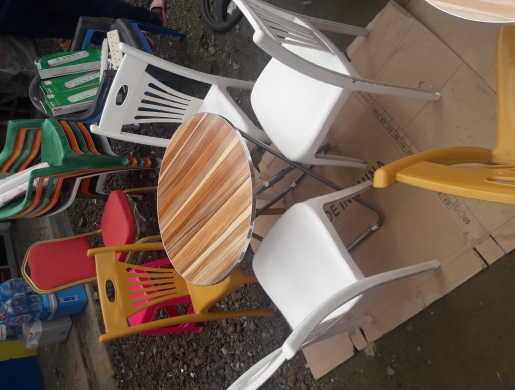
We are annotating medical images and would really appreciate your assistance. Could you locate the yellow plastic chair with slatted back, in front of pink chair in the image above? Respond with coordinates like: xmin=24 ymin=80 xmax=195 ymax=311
xmin=88 ymin=243 xmax=273 ymax=343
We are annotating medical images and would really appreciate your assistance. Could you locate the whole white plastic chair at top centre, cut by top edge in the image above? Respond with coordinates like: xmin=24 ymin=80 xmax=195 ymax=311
xmin=234 ymin=0 xmax=440 ymax=168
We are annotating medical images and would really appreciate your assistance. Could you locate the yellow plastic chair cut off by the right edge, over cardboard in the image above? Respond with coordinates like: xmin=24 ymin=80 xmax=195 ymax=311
xmin=374 ymin=25 xmax=515 ymax=204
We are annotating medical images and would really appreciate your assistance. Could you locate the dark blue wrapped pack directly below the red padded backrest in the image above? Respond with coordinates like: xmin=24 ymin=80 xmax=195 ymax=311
xmin=40 ymin=286 xmax=88 ymax=321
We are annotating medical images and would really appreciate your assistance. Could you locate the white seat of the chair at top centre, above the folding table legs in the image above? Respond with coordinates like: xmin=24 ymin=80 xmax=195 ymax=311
xmin=251 ymin=58 xmax=352 ymax=164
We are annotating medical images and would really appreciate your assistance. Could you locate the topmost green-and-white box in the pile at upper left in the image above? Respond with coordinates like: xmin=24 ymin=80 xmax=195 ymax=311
xmin=34 ymin=49 xmax=102 ymax=80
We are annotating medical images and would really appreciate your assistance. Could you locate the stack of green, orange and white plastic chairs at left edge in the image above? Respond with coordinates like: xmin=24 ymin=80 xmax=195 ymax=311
xmin=0 ymin=119 xmax=160 ymax=219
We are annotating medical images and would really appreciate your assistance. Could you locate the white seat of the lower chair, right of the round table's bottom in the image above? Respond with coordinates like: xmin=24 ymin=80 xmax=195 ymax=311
xmin=253 ymin=198 xmax=364 ymax=329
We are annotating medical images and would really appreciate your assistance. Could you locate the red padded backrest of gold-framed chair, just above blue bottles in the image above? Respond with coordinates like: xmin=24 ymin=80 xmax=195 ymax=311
xmin=27 ymin=237 xmax=97 ymax=290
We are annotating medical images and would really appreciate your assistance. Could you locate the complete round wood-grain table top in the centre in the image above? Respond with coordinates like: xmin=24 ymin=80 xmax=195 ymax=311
xmin=157 ymin=114 xmax=255 ymax=286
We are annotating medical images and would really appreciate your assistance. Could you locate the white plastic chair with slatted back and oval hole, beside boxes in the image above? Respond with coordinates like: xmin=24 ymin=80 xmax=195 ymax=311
xmin=91 ymin=43 xmax=270 ymax=147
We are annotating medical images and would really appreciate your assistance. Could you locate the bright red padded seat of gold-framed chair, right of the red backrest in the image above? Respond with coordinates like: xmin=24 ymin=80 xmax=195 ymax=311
xmin=100 ymin=190 xmax=138 ymax=261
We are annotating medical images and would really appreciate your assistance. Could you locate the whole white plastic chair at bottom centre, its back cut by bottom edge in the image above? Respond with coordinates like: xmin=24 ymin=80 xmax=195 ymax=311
xmin=229 ymin=181 xmax=440 ymax=390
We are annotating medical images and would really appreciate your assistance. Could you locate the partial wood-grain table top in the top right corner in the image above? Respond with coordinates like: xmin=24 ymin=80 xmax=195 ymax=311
xmin=426 ymin=0 xmax=515 ymax=23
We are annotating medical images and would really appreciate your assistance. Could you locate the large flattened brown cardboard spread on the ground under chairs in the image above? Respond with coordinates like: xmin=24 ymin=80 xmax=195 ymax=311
xmin=254 ymin=0 xmax=515 ymax=378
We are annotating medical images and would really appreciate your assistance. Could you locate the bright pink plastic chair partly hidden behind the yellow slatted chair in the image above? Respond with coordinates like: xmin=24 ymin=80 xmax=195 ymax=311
xmin=129 ymin=258 xmax=204 ymax=334
